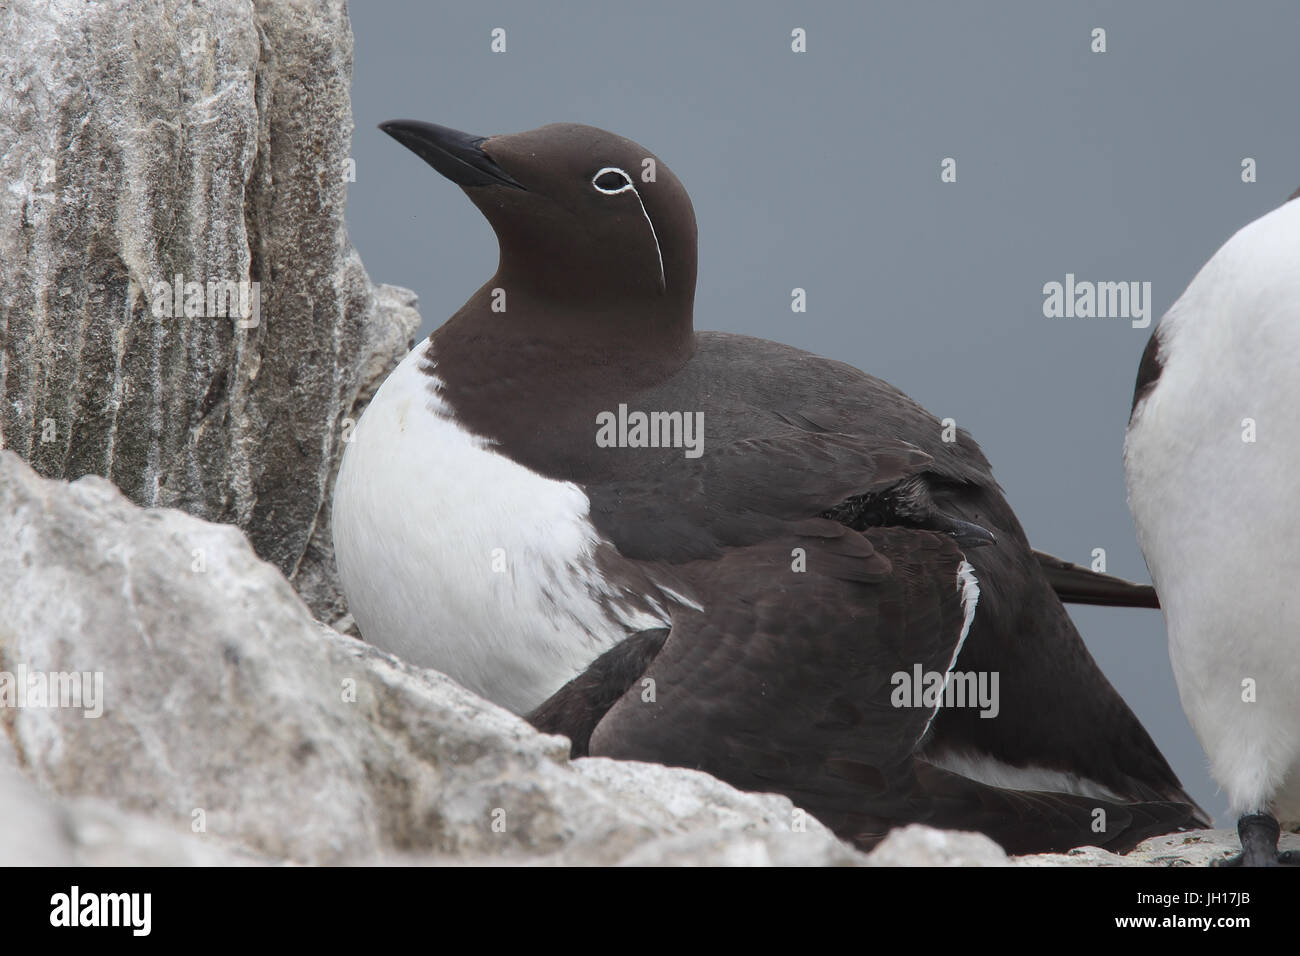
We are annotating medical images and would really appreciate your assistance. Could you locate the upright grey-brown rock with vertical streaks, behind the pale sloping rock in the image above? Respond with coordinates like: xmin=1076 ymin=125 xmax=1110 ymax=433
xmin=0 ymin=0 xmax=419 ymax=620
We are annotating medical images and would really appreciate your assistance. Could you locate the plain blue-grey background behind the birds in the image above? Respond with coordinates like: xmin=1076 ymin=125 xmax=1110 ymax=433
xmin=347 ymin=0 xmax=1300 ymax=823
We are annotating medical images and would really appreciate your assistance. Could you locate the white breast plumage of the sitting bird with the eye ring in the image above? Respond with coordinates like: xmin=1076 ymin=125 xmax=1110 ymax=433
xmin=333 ymin=342 xmax=667 ymax=713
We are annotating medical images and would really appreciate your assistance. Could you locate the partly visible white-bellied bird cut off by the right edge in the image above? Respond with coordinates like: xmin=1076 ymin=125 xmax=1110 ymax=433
xmin=1125 ymin=191 xmax=1300 ymax=866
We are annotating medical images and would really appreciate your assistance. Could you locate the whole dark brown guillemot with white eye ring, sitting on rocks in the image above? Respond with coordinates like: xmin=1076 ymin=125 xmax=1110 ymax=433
xmin=334 ymin=121 xmax=1199 ymax=852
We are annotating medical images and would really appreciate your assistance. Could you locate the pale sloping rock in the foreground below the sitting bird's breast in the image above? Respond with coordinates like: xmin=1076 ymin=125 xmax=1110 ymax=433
xmin=0 ymin=451 xmax=862 ymax=865
